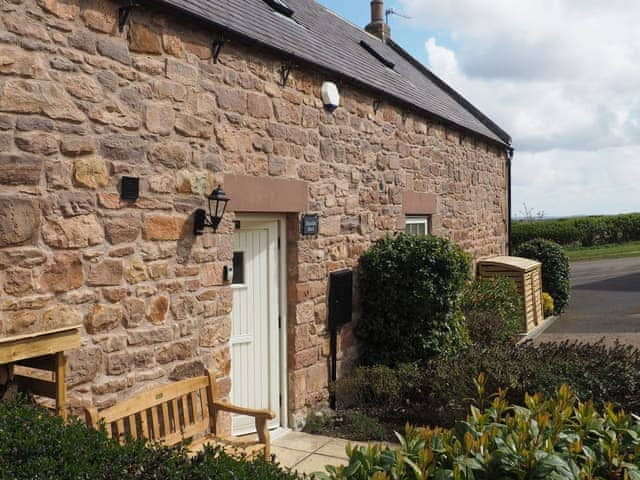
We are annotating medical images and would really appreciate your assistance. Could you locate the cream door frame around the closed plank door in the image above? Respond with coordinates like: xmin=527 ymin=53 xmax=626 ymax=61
xmin=231 ymin=213 xmax=289 ymax=428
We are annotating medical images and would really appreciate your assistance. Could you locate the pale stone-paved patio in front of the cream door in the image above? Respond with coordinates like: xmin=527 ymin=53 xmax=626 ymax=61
xmin=271 ymin=432 xmax=390 ymax=474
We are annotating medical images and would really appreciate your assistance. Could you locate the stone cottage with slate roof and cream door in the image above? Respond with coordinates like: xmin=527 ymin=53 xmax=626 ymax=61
xmin=0 ymin=0 xmax=511 ymax=432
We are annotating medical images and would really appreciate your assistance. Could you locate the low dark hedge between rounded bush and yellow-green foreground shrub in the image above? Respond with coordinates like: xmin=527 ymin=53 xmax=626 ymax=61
xmin=333 ymin=342 xmax=640 ymax=427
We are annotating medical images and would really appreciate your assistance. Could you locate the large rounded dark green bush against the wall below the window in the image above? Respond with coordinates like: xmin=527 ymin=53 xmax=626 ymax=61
xmin=356 ymin=234 xmax=470 ymax=365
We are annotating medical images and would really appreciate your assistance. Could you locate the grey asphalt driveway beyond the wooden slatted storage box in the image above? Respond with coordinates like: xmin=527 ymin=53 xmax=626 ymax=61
xmin=536 ymin=257 xmax=640 ymax=348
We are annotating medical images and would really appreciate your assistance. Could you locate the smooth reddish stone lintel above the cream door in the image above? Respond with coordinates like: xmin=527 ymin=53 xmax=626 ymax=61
xmin=224 ymin=175 xmax=309 ymax=213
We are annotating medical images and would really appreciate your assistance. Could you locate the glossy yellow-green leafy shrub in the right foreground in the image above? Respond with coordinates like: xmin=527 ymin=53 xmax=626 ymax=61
xmin=320 ymin=378 xmax=640 ymax=480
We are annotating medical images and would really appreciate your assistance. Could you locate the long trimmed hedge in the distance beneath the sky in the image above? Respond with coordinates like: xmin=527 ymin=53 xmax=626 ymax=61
xmin=511 ymin=213 xmax=640 ymax=247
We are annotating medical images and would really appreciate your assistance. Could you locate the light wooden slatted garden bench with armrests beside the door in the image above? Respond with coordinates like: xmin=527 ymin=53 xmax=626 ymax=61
xmin=86 ymin=371 xmax=276 ymax=459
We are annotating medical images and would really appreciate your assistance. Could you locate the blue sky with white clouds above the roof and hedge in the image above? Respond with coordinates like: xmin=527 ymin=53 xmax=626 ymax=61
xmin=319 ymin=0 xmax=640 ymax=216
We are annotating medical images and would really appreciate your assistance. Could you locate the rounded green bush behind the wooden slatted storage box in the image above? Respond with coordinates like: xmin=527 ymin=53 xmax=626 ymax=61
xmin=515 ymin=239 xmax=571 ymax=315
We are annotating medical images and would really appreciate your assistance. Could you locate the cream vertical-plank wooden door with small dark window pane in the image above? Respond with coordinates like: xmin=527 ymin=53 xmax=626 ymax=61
xmin=231 ymin=220 xmax=280 ymax=435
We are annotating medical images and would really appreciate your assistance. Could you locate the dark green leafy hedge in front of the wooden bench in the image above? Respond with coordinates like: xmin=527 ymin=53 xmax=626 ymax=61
xmin=0 ymin=399 xmax=299 ymax=480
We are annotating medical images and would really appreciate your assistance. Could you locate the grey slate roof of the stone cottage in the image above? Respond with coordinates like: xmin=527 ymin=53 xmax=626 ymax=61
xmin=154 ymin=0 xmax=511 ymax=145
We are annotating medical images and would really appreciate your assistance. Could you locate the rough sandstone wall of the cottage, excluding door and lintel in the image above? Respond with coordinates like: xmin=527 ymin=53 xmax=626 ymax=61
xmin=0 ymin=0 xmax=506 ymax=428
